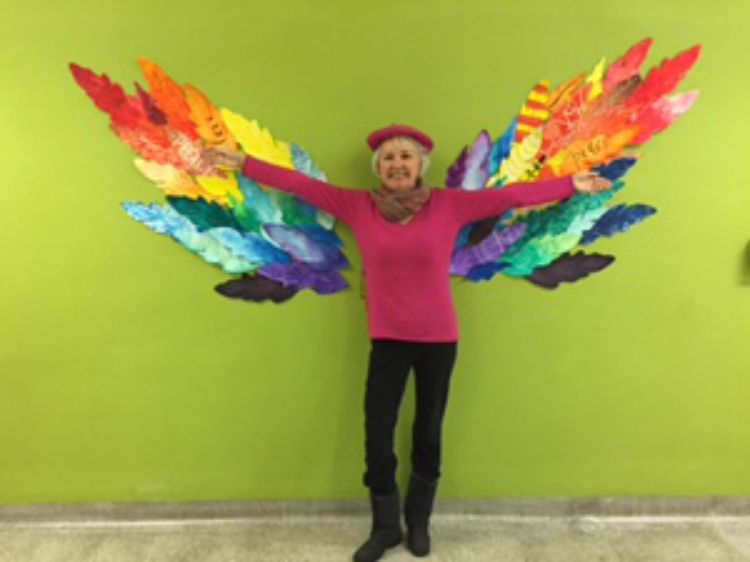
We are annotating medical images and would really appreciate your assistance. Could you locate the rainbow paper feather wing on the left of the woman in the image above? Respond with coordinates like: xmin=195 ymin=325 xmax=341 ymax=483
xmin=70 ymin=60 xmax=349 ymax=302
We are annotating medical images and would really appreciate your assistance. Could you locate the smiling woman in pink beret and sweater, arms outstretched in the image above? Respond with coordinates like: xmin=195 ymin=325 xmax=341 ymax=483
xmin=209 ymin=125 xmax=610 ymax=562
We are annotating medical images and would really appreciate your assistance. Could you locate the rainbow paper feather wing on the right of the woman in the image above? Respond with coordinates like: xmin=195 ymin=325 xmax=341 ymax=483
xmin=446 ymin=39 xmax=700 ymax=288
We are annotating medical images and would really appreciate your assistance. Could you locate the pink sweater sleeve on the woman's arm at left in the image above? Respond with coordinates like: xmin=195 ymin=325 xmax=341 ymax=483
xmin=242 ymin=156 xmax=369 ymax=224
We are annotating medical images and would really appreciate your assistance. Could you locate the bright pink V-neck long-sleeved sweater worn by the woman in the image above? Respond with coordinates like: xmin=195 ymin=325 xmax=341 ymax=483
xmin=243 ymin=158 xmax=575 ymax=342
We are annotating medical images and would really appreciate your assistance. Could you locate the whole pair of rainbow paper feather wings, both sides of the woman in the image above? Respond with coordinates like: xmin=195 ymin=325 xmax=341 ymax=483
xmin=70 ymin=40 xmax=700 ymax=302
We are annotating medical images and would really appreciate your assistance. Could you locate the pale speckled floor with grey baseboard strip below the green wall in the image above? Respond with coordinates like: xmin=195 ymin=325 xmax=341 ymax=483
xmin=0 ymin=498 xmax=750 ymax=562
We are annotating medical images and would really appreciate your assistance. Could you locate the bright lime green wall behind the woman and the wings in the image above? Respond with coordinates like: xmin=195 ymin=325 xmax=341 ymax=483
xmin=0 ymin=0 xmax=750 ymax=498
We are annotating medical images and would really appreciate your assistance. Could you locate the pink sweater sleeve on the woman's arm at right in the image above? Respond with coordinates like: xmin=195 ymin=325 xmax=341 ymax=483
xmin=448 ymin=176 xmax=576 ymax=225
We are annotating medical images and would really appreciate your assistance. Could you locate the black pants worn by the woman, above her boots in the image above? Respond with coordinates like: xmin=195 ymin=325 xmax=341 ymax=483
xmin=364 ymin=334 xmax=457 ymax=495
